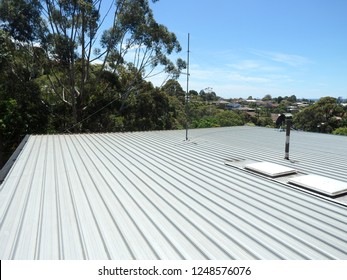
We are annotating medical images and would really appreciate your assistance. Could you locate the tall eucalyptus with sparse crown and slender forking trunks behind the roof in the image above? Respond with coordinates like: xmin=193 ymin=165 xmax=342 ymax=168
xmin=44 ymin=0 xmax=184 ymax=130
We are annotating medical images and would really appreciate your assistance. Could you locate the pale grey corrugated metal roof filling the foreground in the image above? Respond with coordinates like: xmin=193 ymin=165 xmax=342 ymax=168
xmin=0 ymin=127 xmax=347 ymax=260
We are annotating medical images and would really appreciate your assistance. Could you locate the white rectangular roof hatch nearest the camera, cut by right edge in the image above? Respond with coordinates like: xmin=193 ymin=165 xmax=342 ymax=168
xmin=288 ymin=174 xmax=347 ymax=197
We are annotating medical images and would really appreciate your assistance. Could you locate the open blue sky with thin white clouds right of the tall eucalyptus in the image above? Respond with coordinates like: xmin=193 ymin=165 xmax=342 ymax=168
xmin=147 ymin=0 xmax=347 ymax=98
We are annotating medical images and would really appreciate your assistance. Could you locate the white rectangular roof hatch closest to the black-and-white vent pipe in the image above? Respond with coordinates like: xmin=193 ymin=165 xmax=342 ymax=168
xmin=245 ymin=161 xmax=297 ymax=177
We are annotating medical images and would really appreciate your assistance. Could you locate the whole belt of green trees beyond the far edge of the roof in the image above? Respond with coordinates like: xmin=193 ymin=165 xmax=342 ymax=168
xmin=0 ymin=0 xmax=347 ymax=170
